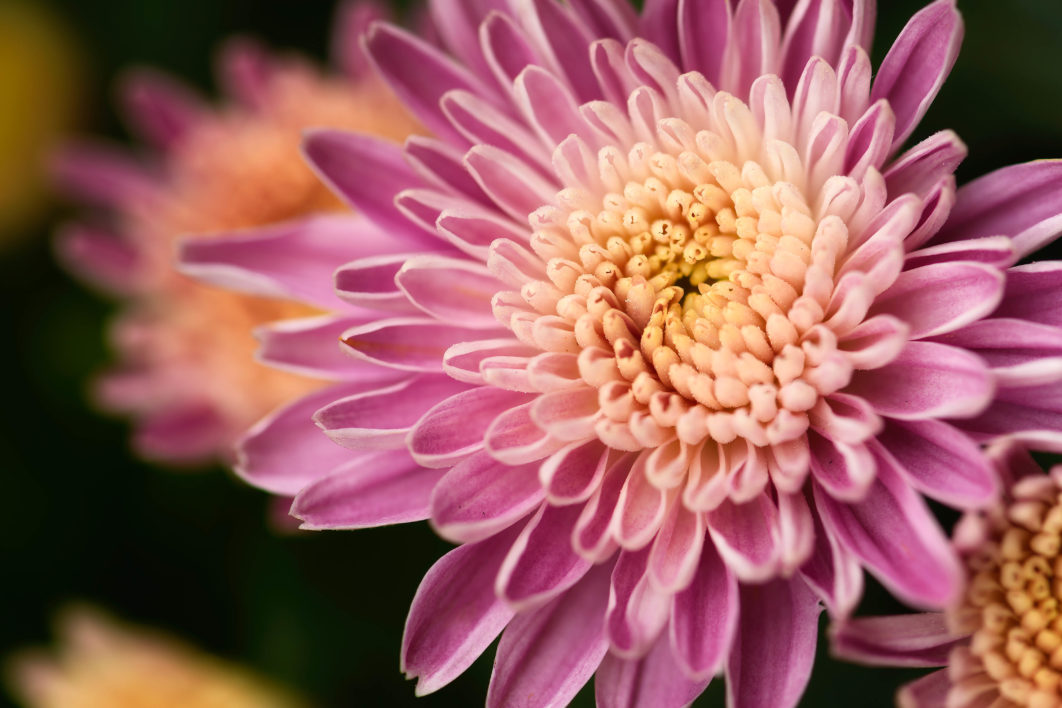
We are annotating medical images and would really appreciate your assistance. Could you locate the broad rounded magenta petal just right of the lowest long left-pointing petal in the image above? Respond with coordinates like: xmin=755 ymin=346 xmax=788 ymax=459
xmin=431 ymin=452 xmax=545 ymax=543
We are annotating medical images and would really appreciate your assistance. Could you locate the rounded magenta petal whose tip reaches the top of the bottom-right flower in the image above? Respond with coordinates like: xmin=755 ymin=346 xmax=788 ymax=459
xmin=877 ymin=419 xmax=999 ymax=508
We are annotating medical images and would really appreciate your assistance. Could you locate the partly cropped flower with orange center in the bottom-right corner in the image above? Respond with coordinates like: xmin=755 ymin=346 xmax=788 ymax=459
xmin=833 ymin=443 xmax=1062 ymax=708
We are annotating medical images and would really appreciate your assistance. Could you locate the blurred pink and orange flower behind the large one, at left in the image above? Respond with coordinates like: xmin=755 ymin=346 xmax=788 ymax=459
xmin=56 ymin=5 xmax=415 ymax=463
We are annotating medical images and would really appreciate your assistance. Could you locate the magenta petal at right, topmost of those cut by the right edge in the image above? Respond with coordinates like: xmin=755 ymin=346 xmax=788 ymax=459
xmin=936 ymin=160 xmax=1062 ymax=257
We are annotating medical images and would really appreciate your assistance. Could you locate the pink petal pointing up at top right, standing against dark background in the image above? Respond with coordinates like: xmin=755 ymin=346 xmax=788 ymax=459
xmin=871 ymin=0 xmax=962 ymax=149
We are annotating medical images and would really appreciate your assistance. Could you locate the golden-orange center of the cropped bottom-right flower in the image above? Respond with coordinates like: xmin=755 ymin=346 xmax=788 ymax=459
xmin=952 ymin=476 xmax=1062 ymax=706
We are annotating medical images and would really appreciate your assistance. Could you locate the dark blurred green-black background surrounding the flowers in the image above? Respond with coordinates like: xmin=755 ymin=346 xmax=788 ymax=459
xmin=0 ymin=0 xmax=1062 ymax=708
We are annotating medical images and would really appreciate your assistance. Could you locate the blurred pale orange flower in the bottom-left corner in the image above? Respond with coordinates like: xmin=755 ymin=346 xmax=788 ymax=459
xmin=8 ymin=608 xmax=303 ymax=708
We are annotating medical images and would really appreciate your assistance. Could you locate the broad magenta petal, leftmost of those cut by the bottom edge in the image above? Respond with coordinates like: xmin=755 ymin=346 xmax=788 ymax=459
xmin=486 ymin=564 xmax=612 ymax=708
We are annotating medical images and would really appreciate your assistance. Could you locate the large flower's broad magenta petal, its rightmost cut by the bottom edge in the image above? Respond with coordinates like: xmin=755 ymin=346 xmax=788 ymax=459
xmin=726 ymin=579 xmax=821 ymax=708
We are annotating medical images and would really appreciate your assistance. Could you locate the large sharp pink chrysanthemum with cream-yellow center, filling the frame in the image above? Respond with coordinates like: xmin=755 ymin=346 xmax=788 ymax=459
xmin=185 ymin=0 xmax=1062 ymax=707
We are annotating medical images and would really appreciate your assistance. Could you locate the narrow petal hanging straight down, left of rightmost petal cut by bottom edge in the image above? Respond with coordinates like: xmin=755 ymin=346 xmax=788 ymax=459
xmin=670 ymin=545 xmax=739 ymax=678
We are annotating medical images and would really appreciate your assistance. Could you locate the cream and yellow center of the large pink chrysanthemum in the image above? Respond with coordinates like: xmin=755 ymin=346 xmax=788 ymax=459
xmin=517 ymin=93 xmax=852 ymax=449
